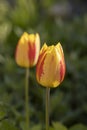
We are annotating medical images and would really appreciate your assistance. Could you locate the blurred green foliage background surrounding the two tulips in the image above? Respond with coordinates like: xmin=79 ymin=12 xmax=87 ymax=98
xmin=0 ymin=0 xmax=87 ymax=130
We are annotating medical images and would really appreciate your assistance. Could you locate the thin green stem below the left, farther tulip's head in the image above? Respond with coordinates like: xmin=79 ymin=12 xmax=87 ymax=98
xmin=25 ymin=68 xmax=29 ymax=130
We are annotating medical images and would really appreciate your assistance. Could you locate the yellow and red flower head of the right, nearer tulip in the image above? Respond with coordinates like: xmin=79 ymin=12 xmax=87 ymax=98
xmin=36 ymin=43 xmax=65 ymax=87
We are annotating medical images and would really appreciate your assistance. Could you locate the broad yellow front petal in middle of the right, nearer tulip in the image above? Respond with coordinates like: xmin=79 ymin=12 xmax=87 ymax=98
xmin=40 ymin=46 xmax=60 ymax=87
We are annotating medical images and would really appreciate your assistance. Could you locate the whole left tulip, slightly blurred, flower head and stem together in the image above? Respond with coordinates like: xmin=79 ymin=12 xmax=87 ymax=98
xmin=15 ymin=32 xmax=40 ymax=130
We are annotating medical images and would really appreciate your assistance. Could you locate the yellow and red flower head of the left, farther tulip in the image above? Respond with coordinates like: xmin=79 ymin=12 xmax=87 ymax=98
xmin=15 ymin=32 xmax=40 ymax=67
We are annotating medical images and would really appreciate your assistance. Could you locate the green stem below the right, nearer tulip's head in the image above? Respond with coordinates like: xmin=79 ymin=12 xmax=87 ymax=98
xmin=46 ymin=87 xmax=50 ymax=130
